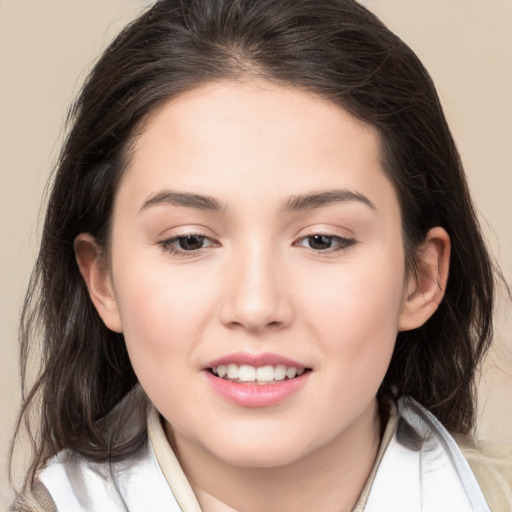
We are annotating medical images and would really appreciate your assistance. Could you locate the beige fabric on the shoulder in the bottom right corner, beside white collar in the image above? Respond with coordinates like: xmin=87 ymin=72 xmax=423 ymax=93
xmin=454 ymin=434 xmax=512 ymax=512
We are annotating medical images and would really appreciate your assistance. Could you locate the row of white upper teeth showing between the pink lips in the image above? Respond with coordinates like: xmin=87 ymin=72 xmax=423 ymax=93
xmin=209 ymin=363 xmax=310 ymax=385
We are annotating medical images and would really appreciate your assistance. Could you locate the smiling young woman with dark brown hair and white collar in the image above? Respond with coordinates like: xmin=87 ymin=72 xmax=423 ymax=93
xmin=10 ymin=0 xmax=512 ymax=512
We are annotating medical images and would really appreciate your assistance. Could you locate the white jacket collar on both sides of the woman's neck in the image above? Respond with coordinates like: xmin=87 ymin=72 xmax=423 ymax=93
xmin=39 ymin=397 xmax=492 ymax=512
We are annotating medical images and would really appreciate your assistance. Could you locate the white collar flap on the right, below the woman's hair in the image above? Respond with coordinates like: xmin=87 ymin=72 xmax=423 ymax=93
xmin=364 ymin=397 xmax=490 ymax=512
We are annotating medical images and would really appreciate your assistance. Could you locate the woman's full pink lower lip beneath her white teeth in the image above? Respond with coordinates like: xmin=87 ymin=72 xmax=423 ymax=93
xmin=204 ymin=370 xmax=311 ymax=407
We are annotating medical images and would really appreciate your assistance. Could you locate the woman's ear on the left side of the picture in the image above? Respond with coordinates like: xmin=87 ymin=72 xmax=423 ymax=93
xmin=74 ymin=233 xmax=123 ymax=332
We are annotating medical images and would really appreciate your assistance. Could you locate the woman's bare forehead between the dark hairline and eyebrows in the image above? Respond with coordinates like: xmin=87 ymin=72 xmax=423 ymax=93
xmin=121 ymin=81 xmax=396 ymax=218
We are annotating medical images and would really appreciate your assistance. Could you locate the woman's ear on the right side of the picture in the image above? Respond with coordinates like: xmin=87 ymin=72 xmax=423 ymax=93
xmin=398 ymin=227 xmax=450 ymax=331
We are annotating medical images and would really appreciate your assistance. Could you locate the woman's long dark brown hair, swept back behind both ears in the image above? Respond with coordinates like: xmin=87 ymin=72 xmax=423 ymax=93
xmin=11 ymin=0 xmax=495 ymax=496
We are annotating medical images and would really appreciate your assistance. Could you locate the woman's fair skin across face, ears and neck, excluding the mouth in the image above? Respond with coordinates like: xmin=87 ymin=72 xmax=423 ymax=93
xmin=75 ymin=82 xmax=449 ymax=511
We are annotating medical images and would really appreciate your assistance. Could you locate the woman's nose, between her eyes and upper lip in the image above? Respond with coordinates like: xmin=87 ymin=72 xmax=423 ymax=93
xmin=220 ymin=243 xmax=293 ymax=333
